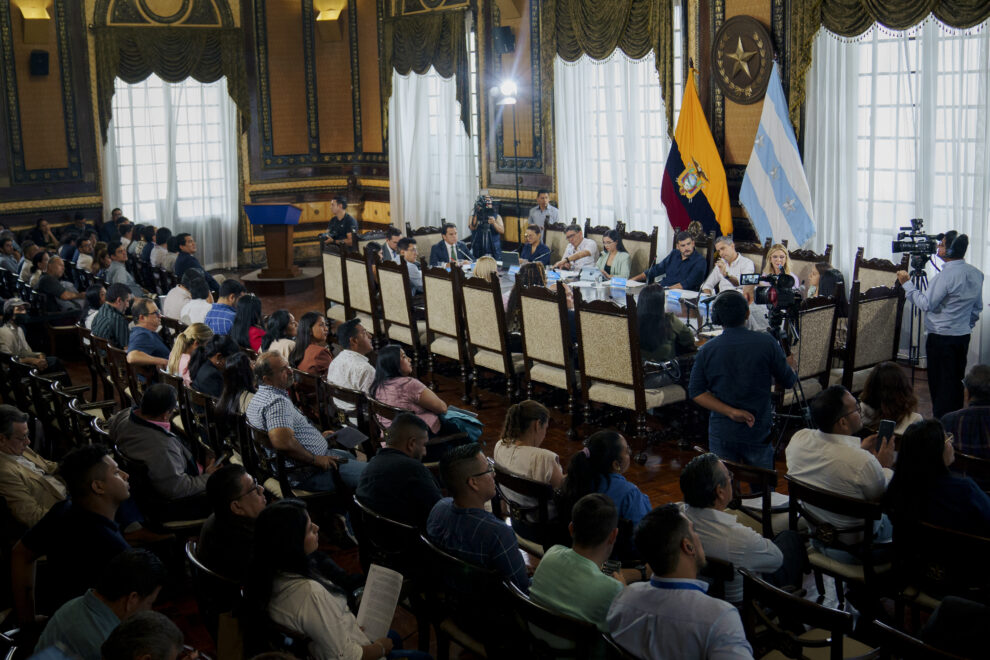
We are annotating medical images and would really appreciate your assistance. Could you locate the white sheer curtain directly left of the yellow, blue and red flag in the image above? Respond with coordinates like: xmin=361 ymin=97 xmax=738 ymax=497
xmin=554 ymin=50 xmax=676 ymax=242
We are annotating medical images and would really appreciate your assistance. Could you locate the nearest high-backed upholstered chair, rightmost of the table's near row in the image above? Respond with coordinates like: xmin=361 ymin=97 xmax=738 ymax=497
xmin=574 ymin=290 xmax=687 ymax=462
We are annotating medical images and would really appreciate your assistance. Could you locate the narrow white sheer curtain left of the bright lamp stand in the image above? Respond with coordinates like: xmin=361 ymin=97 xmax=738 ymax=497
xmin=388 ymin=67 xmax=478 ymax=233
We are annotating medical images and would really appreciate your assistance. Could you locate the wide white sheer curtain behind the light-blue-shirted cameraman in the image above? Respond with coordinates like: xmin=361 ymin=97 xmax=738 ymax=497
xmin=805 ymin=19 xmax=990 ymax=365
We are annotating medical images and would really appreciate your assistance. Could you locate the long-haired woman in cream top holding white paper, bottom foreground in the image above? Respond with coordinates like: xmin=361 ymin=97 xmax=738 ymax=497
xmin=241 ymin=499 xmax=400 ymax=660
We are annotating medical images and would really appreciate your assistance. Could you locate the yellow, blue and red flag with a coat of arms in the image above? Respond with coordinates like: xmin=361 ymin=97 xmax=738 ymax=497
xmin=660 ymin=69 xmax=732 ymax=234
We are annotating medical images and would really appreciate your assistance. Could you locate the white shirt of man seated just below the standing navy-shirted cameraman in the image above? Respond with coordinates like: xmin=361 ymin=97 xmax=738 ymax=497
xmin=681 ymin=504 xmax=784 ymax=603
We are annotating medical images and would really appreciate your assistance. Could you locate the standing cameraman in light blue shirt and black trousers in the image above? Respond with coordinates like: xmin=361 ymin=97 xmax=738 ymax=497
xmin=897 ymin=231 xmax=983 ymax=418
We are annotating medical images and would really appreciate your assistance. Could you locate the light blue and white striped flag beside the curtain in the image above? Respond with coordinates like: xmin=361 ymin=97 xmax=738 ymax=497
xmin=739 ymin=62 xmax=815 ymax=249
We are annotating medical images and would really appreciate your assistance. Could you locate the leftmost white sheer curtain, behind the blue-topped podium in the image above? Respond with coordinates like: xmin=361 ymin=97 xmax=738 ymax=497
xmin=103 ymin=75 xmax=240 ymax=268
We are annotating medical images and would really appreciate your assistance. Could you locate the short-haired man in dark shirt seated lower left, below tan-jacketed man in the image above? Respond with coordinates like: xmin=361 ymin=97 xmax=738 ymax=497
xmin=11 ymin=445 xmax=130 ymax=625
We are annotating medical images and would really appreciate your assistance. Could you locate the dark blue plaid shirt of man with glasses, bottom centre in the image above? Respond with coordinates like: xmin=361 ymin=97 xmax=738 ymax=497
xmin=426 ymin=497 xmax=529 ymax=593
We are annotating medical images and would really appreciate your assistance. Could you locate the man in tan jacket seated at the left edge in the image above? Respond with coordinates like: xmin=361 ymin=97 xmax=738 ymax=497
xmin=0 ymin=404 xmax=66 ymax=527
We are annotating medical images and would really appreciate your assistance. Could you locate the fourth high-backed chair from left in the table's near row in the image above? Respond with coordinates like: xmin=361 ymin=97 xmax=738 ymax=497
xmin=423 ymin=268 xmax=471 ymax=401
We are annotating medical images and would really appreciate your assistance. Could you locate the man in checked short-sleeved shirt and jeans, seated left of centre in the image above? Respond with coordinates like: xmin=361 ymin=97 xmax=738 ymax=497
xmin=245 ymin=351 xmax=368 ymax=491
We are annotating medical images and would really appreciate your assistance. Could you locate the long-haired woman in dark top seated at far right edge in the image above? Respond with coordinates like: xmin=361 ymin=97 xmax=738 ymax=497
xmin=885 ymin=419 xmax=990 ymax=545
